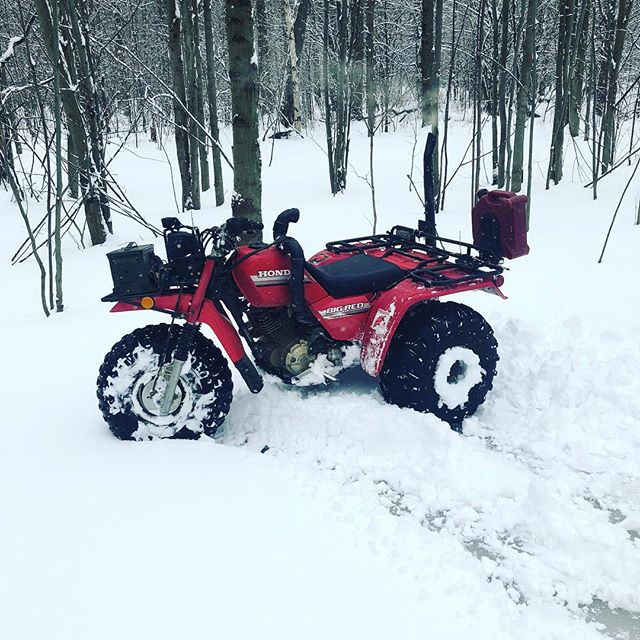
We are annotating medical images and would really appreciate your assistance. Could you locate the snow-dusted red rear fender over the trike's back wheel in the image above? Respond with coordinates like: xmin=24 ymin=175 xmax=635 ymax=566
xmin=360 ymin=276 xmax=506 ymax=377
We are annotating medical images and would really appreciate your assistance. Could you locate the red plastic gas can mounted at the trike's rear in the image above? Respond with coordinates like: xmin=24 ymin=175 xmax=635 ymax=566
xmin=471 ymin=191 xmax=529 ymax=260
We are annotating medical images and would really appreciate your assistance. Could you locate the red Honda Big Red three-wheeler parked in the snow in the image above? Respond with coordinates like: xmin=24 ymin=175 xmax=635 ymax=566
xmin=98 ymin=192 xmax=528 ymax=440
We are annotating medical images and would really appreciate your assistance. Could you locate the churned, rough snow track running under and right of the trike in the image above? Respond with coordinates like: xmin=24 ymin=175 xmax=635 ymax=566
xmin=224 ymin=320 xmax=640 ymax=638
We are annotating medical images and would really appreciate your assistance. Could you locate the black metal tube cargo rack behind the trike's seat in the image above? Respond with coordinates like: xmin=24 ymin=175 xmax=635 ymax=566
xmin=327 ymin=226 xmax=504 ymax=287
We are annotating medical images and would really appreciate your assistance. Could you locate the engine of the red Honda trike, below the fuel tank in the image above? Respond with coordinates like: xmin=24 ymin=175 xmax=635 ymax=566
xmin=246 ymin=307 xmax=342 ymax=380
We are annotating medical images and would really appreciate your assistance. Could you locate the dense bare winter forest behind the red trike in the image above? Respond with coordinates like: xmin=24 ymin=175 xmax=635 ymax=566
xmin=0 ymin=0 xmax=640 ymax=316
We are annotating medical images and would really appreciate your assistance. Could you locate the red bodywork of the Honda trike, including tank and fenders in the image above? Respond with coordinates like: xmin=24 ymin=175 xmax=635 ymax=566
xmin=111 ymin=246 xmax=504 ymax=376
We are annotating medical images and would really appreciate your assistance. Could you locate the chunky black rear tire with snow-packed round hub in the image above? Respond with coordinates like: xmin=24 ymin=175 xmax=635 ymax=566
xmin=380 ymin=302 xmax=498 ymax=429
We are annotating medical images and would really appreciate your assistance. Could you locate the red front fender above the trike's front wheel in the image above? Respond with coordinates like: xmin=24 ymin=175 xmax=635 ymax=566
xmin=111 ymin=294 xmax=246 ymax=364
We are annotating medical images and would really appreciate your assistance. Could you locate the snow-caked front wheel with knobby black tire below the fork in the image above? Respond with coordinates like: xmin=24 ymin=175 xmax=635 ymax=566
xmin=98 ymin=324 xmax=233 ymax=440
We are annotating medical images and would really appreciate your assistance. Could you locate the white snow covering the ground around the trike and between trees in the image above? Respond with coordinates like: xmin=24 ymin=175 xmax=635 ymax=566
xmin=0 ymin=116 xmax=640 ymax=640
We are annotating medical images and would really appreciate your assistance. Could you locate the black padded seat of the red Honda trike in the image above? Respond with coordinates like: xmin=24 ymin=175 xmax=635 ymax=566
xmin=306 ymin=253 xmax=404 ymax=298
